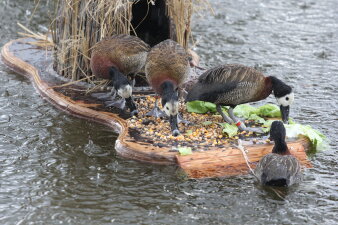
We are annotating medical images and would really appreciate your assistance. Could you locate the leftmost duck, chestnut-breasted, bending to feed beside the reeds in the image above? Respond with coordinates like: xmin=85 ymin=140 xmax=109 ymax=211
xmin=90 ymin=34 xmax=150 ymax=116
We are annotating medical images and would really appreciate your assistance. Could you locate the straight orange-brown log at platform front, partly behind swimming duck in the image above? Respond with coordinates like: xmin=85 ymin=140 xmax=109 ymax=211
xmin=176 ymin=138 xmax=312 ymax=178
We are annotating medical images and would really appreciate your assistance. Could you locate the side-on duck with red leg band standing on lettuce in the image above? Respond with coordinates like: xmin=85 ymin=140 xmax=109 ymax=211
xmin=186 ymin=64 xmax=294 ymax=133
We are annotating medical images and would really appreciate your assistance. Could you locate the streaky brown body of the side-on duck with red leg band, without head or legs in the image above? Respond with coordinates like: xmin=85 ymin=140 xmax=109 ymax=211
xmin=187 ymin=64 xmax=272 ymax=106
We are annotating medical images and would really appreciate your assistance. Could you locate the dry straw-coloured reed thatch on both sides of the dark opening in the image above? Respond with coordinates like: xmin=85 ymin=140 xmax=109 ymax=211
xmin=52 ymin=0 xmax=208 ymax=80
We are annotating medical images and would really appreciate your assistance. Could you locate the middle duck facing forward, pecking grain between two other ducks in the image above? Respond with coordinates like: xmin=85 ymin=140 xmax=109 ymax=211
xmin=145 ymin=39 xmax=191 ymax=136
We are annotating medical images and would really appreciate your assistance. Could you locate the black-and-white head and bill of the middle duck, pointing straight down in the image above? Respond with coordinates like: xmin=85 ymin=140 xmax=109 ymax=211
xmin=161 ymin=81 xmax=180 ymax=136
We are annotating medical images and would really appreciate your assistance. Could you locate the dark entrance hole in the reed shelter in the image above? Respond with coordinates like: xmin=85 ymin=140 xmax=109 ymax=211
xmin=131 ymin=0 xmax=170 ymax=47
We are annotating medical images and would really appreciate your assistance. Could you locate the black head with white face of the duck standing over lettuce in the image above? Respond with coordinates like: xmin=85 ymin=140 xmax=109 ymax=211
xmin=271 ymin=77 xmax=295 ymax=123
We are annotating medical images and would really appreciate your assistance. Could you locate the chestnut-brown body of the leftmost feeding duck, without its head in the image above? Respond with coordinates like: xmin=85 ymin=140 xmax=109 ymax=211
xmin=90 ymin=34 xmax=150 ymax=79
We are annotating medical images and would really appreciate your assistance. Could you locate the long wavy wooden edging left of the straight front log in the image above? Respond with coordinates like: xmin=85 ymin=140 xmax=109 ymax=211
xmin=1 ymin=38 xmax=176 ymax=165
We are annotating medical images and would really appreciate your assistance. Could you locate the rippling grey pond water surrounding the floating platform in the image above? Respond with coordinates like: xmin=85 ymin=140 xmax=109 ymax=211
xmin=0 ymin=0 xmax=338 ymax=224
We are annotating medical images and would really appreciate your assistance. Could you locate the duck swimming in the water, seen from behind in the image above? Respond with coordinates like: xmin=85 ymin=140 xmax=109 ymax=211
xmin=254 ymin=121 xmax=302 ymax=187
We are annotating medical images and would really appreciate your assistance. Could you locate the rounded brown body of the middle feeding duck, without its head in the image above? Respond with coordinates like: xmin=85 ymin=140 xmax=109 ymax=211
xmin=145 ymin=39 xmax=190 ymax=94
